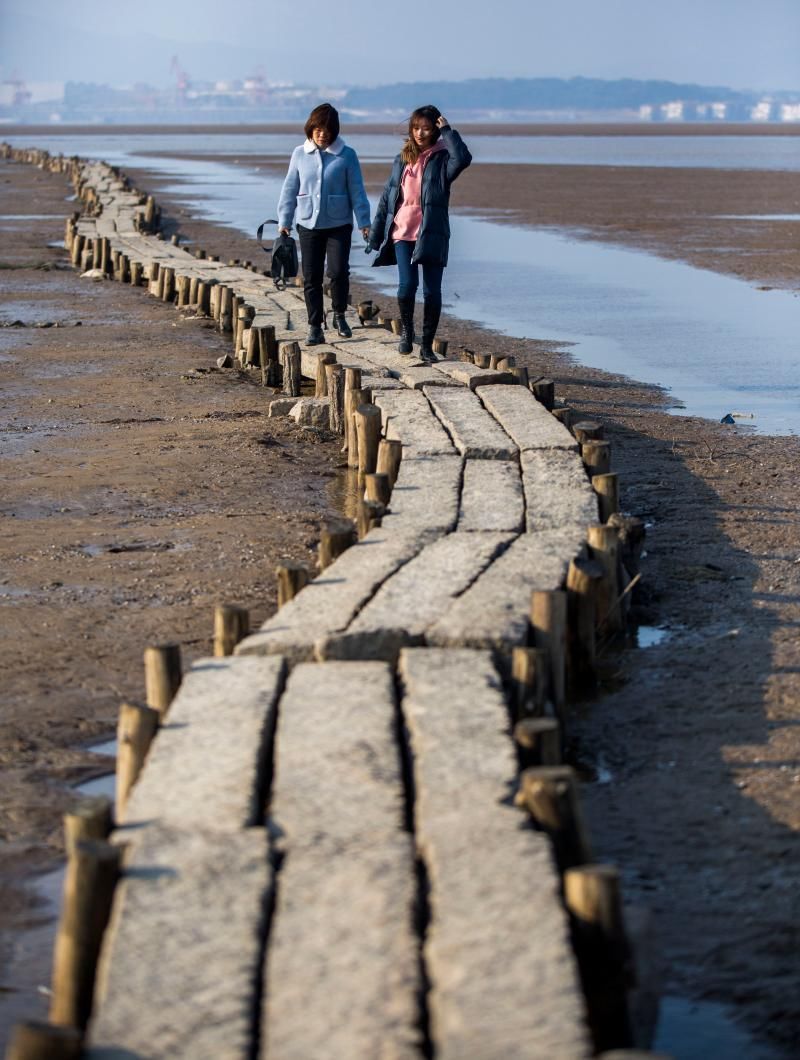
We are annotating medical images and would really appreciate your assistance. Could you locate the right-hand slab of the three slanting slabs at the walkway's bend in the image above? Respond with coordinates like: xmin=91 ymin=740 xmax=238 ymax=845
xmin=425 ymin=530 xmax=583 ymax=653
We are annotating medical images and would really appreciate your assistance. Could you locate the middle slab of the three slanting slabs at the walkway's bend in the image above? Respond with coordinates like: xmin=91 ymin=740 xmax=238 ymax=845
xmin=317 ymin=533 xmax=514 ymax=663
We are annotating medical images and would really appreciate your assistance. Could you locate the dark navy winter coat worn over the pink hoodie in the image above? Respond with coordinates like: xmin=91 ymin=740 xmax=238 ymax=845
xmin=369 ymin=125 xmax=473 ymax=265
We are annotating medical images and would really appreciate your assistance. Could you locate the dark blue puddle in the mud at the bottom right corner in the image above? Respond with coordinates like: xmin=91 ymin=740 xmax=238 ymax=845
xmin=652 ymin=997 xmax=785 ymax=1060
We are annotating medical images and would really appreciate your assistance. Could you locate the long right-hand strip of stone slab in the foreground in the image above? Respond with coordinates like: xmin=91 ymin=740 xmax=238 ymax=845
xmin=399 ymin=649 xmax=592 ymax=1060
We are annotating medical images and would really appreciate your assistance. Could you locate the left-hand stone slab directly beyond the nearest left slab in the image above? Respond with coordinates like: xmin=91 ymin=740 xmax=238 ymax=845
xmin=125 ymin=656 xmax=285 ymax=832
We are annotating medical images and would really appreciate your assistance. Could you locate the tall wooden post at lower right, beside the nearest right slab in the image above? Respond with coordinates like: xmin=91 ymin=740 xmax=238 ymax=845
xmin=564 ymin=865 xmax=633 ymax=1052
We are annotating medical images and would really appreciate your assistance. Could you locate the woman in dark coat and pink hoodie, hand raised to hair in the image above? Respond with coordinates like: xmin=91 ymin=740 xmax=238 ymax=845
xmin=367 ymin=106 xmax=473 ymax=360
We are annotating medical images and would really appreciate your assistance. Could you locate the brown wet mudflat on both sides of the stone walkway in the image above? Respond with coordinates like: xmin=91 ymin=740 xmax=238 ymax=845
xmin=0 ymin=134 xmax=800 ymax=1056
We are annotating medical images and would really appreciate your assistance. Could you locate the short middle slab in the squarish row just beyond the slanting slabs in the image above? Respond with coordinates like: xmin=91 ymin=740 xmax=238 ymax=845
xmin=458 ymin=460 xmax=525 ymax=533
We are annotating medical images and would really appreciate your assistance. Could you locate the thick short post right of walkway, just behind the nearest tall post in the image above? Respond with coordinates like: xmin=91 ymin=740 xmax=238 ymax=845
xmin=517 ymin=765 xmax=591 ymax=872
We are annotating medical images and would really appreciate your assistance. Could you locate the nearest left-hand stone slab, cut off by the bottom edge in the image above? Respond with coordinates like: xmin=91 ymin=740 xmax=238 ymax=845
xmin=84 ymin=826 xmax=272 ymax=1060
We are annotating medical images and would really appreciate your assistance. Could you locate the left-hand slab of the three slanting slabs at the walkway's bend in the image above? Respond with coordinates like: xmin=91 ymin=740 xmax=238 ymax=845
xmin=236 ymin=527 xmax=430 ymax=664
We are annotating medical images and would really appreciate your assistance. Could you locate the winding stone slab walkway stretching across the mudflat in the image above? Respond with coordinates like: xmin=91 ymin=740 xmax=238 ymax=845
xmin=6 ymin=147 xmax=627 ymax=1060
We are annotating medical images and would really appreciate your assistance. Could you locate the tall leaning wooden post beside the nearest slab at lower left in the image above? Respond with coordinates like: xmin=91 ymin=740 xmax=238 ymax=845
xmin=50 ymin=840 xmax=122 ymax=1030
